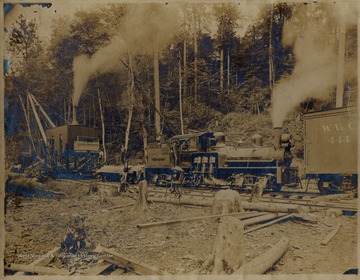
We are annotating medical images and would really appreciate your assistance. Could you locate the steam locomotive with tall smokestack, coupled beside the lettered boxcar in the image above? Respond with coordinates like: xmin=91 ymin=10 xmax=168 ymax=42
xmin=145 ymin=128 xmax=298 ymax=190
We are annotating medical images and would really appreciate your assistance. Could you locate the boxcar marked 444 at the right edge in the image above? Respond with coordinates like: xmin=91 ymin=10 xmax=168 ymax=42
xmin=304 ymin=107 xmax=358 ymax=193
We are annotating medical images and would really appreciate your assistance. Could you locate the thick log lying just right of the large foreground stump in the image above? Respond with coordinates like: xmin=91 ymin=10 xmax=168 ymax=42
xmin=234 ymin=237 xmax=289 ymax=274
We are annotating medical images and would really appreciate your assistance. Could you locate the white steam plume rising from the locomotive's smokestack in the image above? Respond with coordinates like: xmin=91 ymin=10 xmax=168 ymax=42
xmin=271 ymin=3 xmax=356 ymax=127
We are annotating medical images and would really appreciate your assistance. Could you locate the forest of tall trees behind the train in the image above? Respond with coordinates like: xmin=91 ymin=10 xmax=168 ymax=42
xmin=5 ymin=3 xmax=357 ymax=164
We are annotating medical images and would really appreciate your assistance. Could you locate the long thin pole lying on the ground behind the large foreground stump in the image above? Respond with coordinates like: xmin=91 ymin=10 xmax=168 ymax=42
xmin=136 ymin=212 xmax=266 ymax=228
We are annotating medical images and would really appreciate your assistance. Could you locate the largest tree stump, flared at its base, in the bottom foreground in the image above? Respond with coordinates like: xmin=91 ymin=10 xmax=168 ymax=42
xmin=200 ymin=217 xmax=244 ymax=274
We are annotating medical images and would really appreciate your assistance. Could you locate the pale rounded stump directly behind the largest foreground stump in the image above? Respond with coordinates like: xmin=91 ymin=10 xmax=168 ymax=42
xmin=211 ymin=190 xmax=242 ymax=215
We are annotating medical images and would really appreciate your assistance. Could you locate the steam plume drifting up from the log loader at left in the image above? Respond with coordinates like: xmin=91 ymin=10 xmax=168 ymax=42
xmin=73 ymin=3 xmax=179 ymax=106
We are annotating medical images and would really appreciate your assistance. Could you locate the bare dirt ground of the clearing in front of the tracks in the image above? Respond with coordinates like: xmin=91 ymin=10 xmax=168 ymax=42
xmin=5 ymin=181 xmax=357 ymax=275
